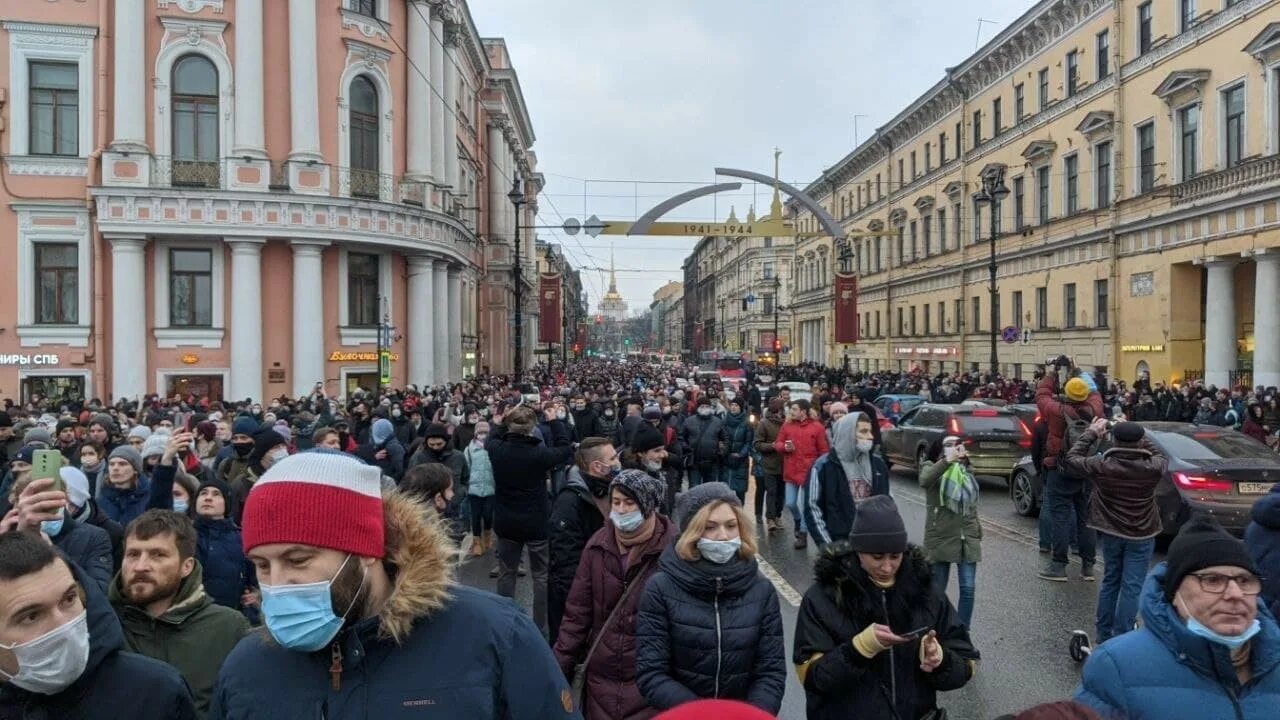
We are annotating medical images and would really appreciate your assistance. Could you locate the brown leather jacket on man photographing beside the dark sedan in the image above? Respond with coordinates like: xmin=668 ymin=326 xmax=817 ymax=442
xmin=1064 ymin=430 xmax=1169 ymax=539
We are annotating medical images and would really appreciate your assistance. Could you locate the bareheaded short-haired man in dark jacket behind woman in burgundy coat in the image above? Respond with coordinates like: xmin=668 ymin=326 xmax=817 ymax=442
xmin=547 ymin=437 xmax=622 ymax=641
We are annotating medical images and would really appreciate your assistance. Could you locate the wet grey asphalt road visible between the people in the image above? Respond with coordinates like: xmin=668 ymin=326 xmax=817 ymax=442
xmin=460 ymin=469 xmax=1162 ymax=720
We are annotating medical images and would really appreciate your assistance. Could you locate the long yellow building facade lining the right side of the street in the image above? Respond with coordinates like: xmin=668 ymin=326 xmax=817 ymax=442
xmin=792 ymin=0 xmax=1280 ymax=387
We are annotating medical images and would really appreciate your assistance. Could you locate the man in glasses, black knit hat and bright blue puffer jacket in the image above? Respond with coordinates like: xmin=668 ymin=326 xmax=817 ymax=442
xmin=1074 ymin=514 xmax=1280 ymax=720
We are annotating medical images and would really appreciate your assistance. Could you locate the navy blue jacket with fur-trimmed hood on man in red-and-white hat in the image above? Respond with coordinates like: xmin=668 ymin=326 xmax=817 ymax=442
xmin=209 ymin=493 xmax=582 ymax=720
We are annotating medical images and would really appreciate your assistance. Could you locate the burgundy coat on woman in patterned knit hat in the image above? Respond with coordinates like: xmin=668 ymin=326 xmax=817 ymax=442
xmin=554 ymin=515 xmax=680 ymax=720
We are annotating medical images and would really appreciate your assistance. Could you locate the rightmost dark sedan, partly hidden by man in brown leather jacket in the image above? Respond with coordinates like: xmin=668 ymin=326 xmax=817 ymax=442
xmin=1009 ymin=423 xmax=1280 ymax=538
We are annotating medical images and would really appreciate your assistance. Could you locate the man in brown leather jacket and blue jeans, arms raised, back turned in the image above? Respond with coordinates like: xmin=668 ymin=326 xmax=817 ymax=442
xmin=1062 ymin=418 xmax=1169 ymax=643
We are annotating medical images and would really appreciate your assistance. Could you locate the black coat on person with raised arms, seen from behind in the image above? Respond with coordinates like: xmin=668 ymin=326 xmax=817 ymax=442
xmin=485 ymin=420 xmax=573 ymax=542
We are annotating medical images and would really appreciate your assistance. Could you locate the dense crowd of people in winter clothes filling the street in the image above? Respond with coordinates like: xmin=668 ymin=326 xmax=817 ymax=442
xmin=0 ymin=357 xmax=1280 ymax=720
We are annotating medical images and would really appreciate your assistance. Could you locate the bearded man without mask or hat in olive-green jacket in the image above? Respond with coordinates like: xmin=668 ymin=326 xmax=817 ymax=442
xmin=108 ymin=510 xmax=248 ymax=716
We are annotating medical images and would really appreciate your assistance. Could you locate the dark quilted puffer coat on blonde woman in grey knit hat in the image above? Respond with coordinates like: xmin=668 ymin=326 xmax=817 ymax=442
xmin=636 ymin=546 xmax=787 ymax=715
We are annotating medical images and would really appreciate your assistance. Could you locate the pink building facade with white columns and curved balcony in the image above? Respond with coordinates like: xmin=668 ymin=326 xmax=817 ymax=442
xmin=0 ymin=0 xmax=543 ymax=400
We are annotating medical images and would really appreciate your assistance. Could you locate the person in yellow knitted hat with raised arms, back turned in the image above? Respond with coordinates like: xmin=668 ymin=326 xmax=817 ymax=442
xmin=1036 ymin=356 xmax=1106 ymax=582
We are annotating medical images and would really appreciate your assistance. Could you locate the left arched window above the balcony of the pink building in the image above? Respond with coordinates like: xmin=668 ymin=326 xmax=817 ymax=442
xmin=170 ymin=55 xmax=219 ymax=187
